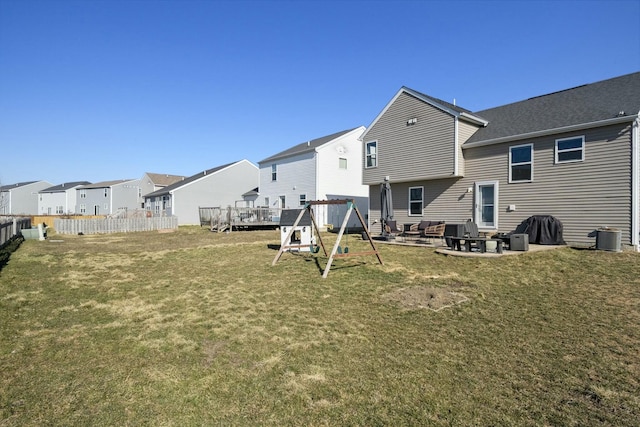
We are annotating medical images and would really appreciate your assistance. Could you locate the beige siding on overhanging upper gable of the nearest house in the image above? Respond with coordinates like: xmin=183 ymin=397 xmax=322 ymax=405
xmin=362 ymin=93 xmax=455 ymax=184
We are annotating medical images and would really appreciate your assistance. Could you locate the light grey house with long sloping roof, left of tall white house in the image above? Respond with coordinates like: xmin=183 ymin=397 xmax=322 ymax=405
xmin=145 ymin=160 xmax=259 ymax=225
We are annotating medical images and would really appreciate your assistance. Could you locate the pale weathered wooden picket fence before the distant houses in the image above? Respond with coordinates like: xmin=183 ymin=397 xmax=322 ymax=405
xmin=53 ymin=216 xmax=178 ymax=234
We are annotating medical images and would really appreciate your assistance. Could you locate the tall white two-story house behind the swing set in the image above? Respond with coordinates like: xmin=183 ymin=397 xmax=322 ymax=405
xmin=257 ymin=126 xmax=369 ymax=228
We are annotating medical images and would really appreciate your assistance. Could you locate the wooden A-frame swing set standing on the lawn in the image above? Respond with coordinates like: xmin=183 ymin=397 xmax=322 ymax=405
xmin=271 ymin=199 xmax=384 ymax=279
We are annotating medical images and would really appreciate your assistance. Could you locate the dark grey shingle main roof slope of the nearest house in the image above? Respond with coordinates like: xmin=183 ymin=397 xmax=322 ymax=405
xmin=467 ymin=72 xmax=640 ymax=144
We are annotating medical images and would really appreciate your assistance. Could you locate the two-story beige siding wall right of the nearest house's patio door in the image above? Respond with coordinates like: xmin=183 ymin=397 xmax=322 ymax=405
xmin=465 ymin=122 xmax=631 ymax=244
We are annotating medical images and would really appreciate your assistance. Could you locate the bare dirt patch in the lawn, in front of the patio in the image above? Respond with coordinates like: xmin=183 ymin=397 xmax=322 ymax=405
xmin=383 ymin=286 xmax=467 ymax=311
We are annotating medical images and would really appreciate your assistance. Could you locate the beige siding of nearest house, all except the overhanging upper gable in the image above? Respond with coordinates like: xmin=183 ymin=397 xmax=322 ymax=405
xmin=369 ymin=125 xmax=631 ymax=245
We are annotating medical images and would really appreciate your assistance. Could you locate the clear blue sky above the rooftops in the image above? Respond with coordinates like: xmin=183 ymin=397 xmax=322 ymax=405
xmin=0 ymin=0 xmax=640 ymax=185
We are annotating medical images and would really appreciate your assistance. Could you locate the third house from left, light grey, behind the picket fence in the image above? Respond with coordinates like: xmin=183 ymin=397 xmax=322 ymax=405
xmin=75 ymin=179 xmax=140 ymax=215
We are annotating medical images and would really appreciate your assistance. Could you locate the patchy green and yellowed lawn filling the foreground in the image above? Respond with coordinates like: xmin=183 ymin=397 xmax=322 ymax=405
xmin=0 ymin=227 xmax=640 ymax=426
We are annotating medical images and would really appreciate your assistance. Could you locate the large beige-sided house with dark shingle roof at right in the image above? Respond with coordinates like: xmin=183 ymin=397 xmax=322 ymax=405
xmin=362 ymin=73 xmax=640 ymax=250
